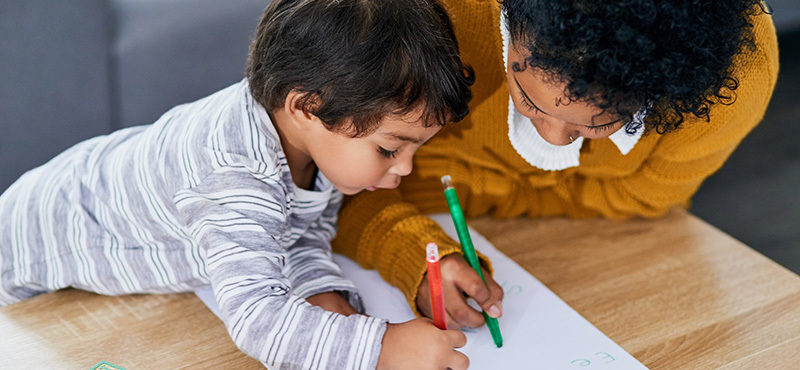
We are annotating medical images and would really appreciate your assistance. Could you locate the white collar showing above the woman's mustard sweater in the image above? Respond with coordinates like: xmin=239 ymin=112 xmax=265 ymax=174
xmin=500 ymin=12 xmax=645 ymax=171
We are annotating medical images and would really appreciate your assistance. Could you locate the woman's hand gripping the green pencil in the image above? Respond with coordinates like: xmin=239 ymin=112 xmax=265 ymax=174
xmin=417 ymin=254 xmax=503 ymax=329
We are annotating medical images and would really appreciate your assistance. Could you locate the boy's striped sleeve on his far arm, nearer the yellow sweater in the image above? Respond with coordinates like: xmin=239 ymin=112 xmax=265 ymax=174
xmin=285 ymin=191 xmax=364 ymax=313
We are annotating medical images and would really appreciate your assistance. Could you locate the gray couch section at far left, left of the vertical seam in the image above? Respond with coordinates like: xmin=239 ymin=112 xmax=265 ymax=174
xmin=0 ymin=0 xmax=111 ymax=192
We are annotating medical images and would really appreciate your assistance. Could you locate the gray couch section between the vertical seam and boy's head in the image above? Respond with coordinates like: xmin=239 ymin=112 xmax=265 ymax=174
xmin=111 ymin=0 xmax=269 ymax=127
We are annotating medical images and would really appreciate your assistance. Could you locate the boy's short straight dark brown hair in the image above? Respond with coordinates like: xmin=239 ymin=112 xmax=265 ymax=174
xmin=247 ymin=0 xmax=474 ymax=137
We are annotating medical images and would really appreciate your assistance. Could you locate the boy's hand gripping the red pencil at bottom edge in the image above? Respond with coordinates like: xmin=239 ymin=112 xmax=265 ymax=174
xmin=377 ymin=317 xmax=469 ymax=370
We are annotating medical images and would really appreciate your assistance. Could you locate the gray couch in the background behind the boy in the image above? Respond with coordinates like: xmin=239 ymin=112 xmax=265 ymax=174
xmin=0 ymin=0 xmax=269 ymax=192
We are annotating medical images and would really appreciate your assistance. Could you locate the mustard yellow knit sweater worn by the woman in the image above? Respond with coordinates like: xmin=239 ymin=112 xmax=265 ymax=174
xmin=334 ymin=0 xmax=778 ymax=309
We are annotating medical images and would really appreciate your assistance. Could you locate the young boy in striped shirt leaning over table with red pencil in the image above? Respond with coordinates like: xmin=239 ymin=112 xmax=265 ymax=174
xmin=0 ymin=0 xmax=473 ymax=369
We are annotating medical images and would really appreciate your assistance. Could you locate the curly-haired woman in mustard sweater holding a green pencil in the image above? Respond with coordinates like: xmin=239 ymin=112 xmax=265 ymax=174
xmin=334 ymin=0 xmax=778 ymax=327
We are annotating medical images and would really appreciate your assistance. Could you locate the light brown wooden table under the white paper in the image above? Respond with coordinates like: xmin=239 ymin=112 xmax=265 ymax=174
xmin=0 ymin=211 xmax=800 ymax=370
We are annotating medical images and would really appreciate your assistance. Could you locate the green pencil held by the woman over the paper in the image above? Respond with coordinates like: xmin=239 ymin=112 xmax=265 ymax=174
xmin=442 ymin=175 xmax=503 ymax=348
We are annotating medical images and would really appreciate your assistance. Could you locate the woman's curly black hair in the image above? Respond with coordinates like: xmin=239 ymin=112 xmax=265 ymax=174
xmin=501 ymin=0 xmax=769 ymax=133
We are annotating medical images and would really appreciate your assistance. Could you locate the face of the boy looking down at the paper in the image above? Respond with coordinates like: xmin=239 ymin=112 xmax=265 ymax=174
xmin=306 ymin=112 xmax=441 ymax=195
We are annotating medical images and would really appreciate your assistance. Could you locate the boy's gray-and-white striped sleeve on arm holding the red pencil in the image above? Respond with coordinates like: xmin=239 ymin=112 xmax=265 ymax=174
xmin=174 ymin=167 xmax=386 ymax=369
